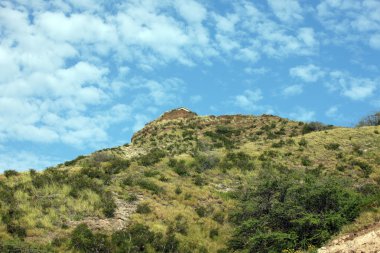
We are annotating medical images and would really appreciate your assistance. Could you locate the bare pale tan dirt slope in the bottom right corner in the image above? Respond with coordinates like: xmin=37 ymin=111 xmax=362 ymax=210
xmin=318 ymin=223 xmax=380 ymax=253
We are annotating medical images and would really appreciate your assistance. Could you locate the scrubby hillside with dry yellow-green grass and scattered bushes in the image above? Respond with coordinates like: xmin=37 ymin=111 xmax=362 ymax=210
xmin=0 ymin=108 xmax=380 ymax=253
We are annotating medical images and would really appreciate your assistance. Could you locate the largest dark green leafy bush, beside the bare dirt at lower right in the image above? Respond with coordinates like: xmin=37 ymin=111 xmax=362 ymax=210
xmin=228 ymin=171 xmax=362 ymax=252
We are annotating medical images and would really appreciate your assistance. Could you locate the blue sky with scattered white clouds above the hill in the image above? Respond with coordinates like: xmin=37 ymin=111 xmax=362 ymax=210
xmin=0 ymin=0 xmax=380 ymax=171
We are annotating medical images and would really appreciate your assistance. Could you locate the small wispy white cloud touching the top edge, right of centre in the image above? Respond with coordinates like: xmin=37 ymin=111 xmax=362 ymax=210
xmin=268 ymin=0 xmax=303 ymax=22
